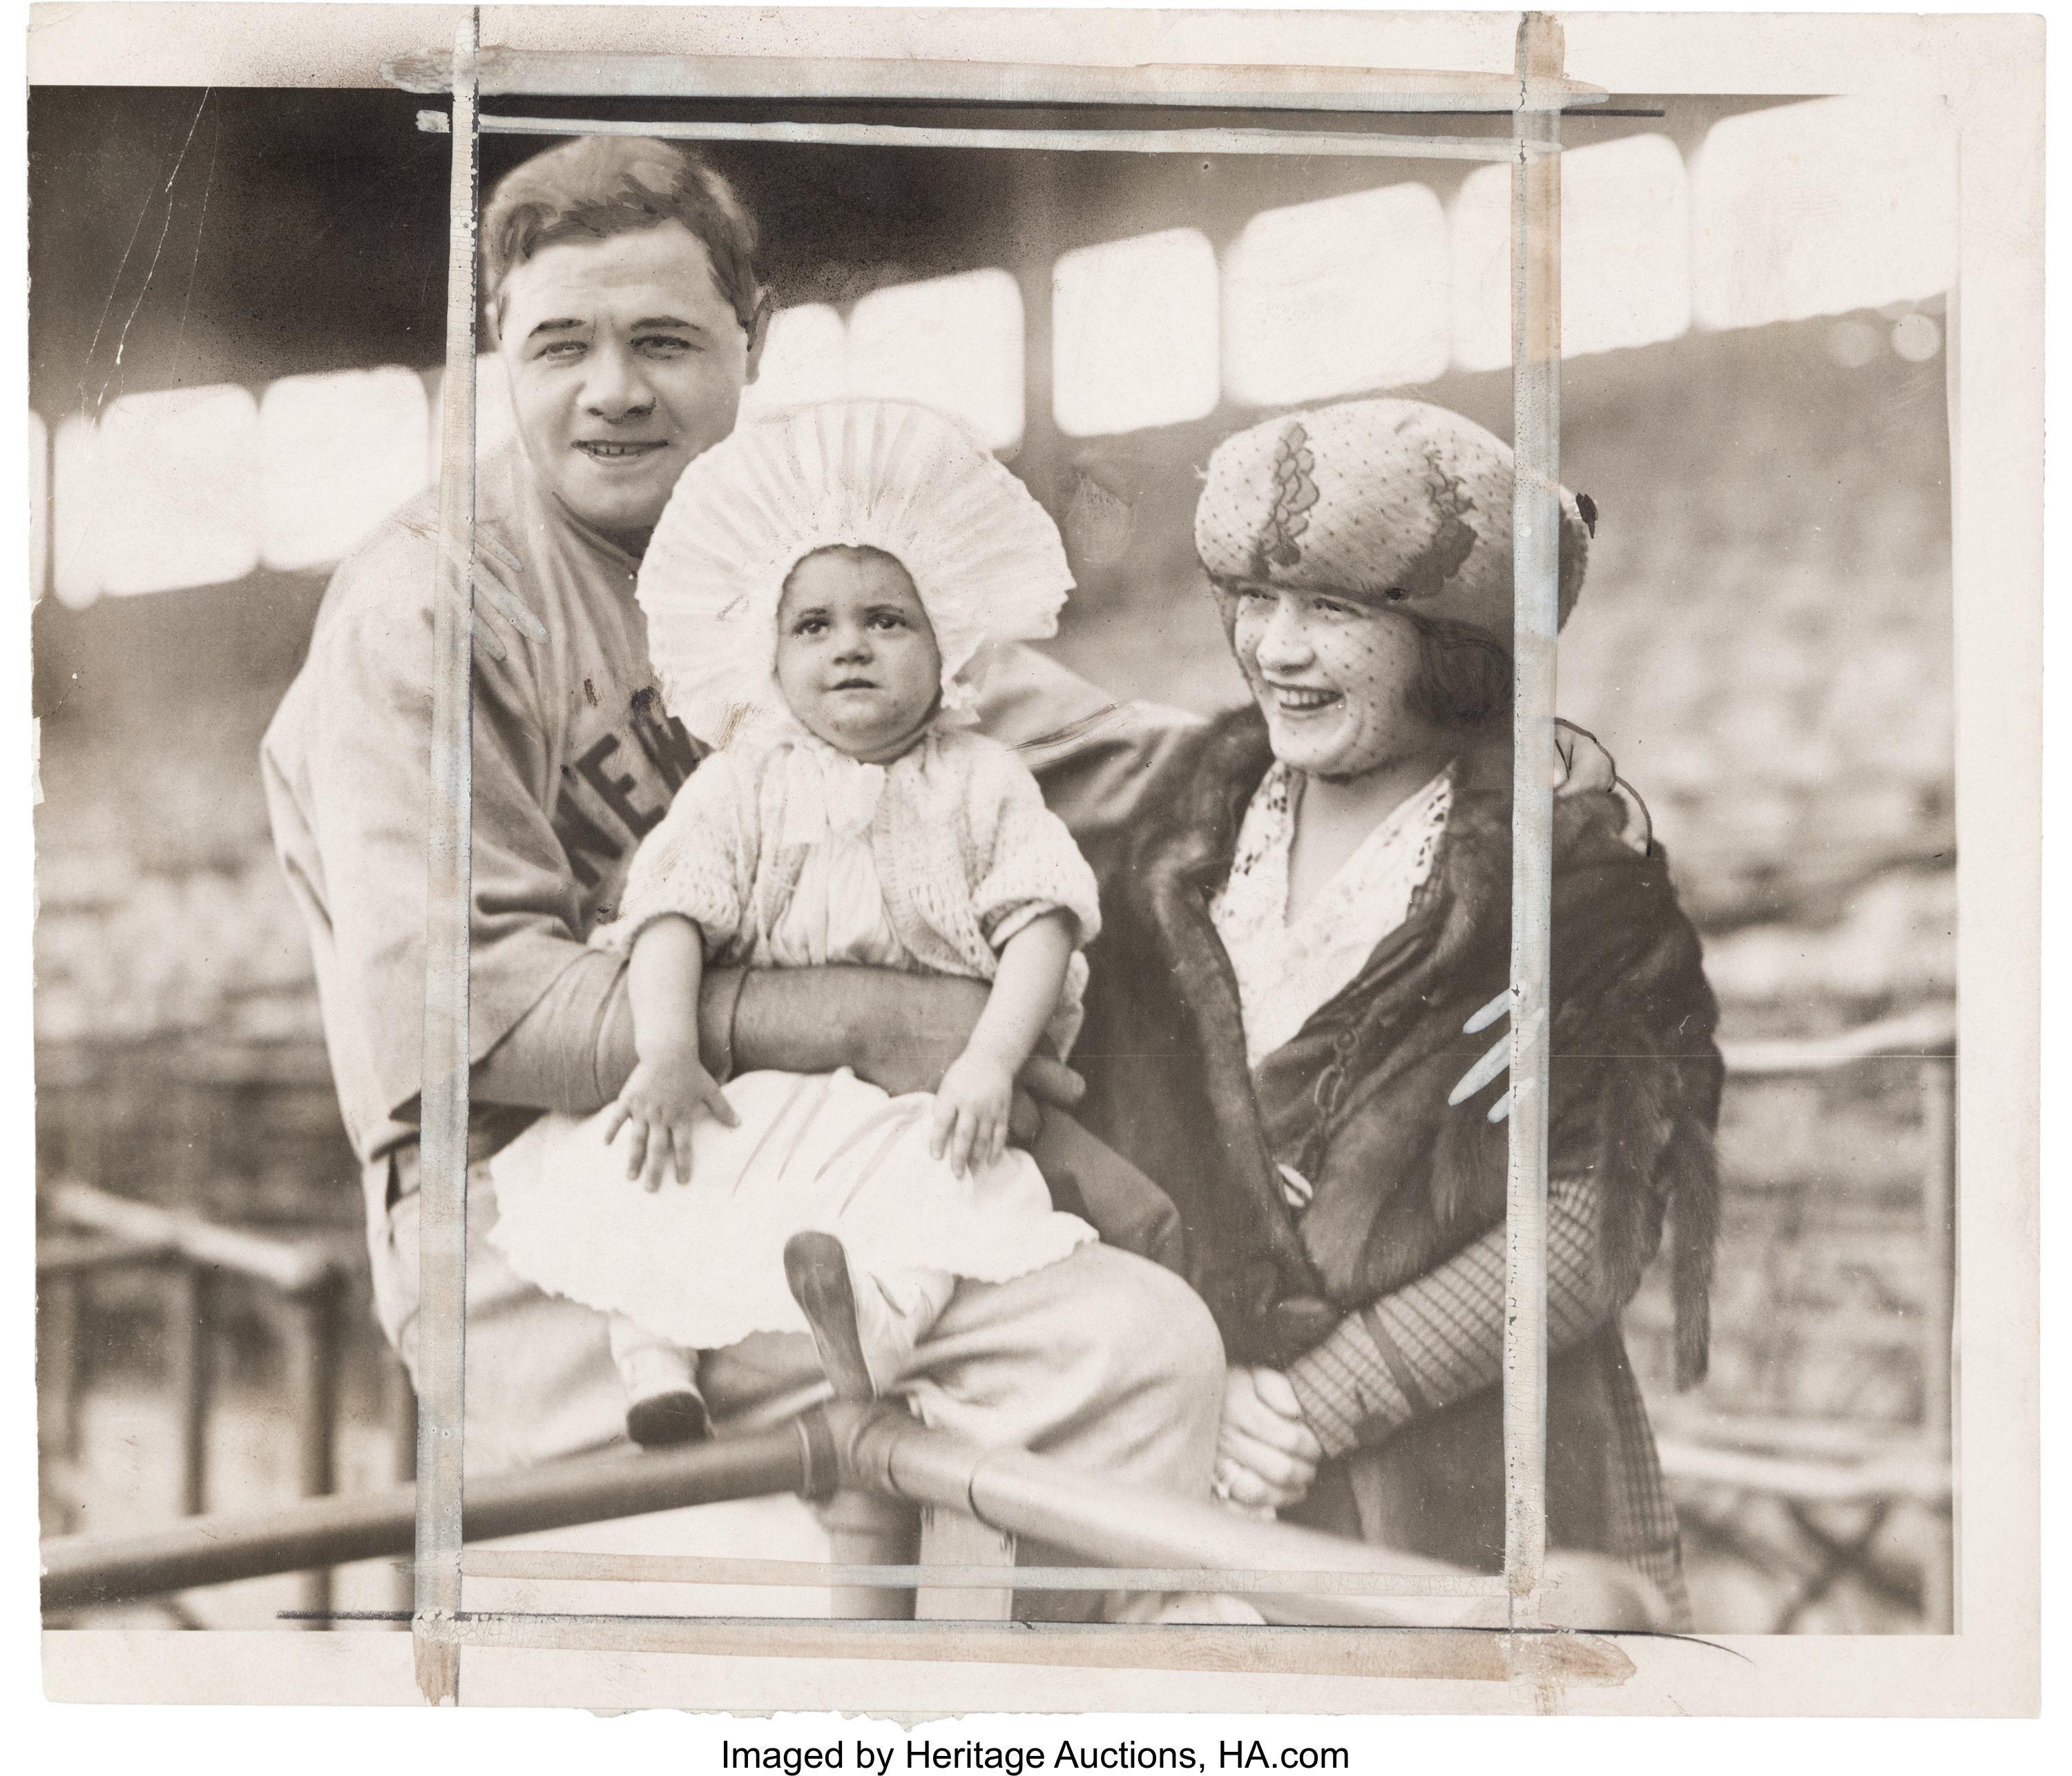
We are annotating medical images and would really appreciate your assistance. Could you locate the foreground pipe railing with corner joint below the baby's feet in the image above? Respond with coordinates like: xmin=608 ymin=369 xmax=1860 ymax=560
xmin=41 ymin=1401 xmax=1664 ymax=1631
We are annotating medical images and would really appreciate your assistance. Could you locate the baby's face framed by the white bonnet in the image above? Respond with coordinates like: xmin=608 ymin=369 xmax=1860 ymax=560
xmin=777 ymin=549 xmax=943 ymax=764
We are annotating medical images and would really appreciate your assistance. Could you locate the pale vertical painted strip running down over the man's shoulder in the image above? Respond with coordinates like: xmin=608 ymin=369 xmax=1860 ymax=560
xmin=410 ymin=10 xmax=481 ymax=1703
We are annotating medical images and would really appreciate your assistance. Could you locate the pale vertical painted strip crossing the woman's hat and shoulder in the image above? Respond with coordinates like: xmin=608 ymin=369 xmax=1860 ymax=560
xmin=1504 ymin=12 xmax=1562 ymax=1627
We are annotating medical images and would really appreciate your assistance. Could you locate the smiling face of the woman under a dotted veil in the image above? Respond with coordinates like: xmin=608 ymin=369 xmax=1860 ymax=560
xmin=1222 ymin=580 xmax=1444 ymax=777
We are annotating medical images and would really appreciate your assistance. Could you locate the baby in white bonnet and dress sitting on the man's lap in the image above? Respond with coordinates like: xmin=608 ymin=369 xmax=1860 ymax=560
xmin=491 ymin=402 xmax=1100 ymax=1445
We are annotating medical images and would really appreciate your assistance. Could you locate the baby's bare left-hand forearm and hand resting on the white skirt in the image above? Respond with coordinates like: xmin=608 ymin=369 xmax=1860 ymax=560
xmin=603 ymin=914 xmax=740 ymax=1190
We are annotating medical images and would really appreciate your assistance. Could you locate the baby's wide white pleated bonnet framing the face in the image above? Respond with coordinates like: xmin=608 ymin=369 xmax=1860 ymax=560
xmin=638 ymin=400 xmax=1071 ymax=746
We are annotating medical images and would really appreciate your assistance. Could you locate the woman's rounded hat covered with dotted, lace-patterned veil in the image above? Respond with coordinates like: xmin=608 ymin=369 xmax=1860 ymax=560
xmin=1193 ymin=400 xmax=1589 ymax=646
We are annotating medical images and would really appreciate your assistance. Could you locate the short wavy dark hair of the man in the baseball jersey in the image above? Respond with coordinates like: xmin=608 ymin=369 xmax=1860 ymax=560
xmin=483 ymin=135 xmax=762 ymax=331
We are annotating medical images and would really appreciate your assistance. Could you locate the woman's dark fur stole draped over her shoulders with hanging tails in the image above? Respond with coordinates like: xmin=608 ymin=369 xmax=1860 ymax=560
xmin=1080 ymin=708 xmax=1720 ymax=1384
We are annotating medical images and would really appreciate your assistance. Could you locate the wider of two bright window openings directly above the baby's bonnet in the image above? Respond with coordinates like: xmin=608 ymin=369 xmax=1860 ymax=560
xmin=850 ymin=269 xmax=1024 ymax=450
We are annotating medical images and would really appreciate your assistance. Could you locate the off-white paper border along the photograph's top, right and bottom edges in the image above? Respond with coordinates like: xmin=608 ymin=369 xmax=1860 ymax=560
xmin=16 ymin=6 xmax=2043 ymax=1714
